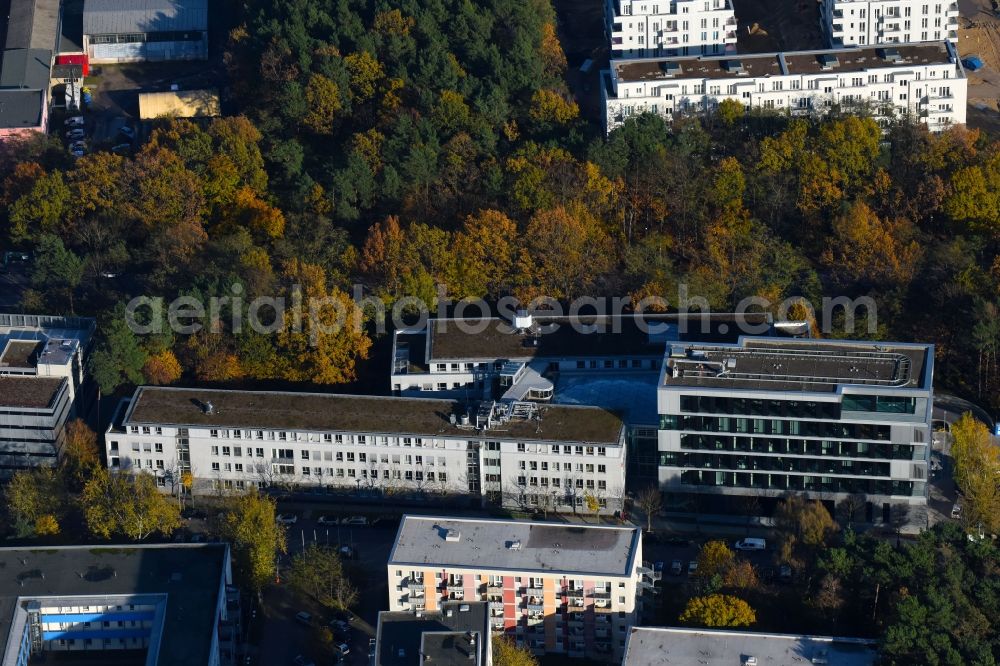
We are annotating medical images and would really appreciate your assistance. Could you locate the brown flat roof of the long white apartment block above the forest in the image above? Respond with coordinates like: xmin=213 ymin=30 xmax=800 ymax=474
xmin=611 ymin=41 xmax=958 ymax=82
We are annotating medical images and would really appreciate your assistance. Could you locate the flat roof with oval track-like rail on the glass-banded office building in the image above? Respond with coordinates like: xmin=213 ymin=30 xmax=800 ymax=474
xmin=663 ymin=338 xmax=933 ymax=392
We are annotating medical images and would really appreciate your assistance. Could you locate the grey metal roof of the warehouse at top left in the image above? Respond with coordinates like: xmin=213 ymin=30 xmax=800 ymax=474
xmin=83 ymin=0 xmax=208 ymax=35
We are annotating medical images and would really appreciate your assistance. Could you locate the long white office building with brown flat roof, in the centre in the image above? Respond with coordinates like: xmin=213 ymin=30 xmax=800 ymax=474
xmin=105 ymin=386 xmax=626 ymax=509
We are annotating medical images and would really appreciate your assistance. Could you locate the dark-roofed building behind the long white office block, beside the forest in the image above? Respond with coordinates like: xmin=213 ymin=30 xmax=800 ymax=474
xmin=390 ymin=311 xmax=788 ymax=401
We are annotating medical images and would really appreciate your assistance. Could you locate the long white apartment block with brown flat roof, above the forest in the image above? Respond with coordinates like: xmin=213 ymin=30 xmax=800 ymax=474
xmin=601 ymin=41 xmax=968 ymax=132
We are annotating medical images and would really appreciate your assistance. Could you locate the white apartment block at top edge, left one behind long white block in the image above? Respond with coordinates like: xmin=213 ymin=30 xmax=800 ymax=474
xmin=604 ymin=0 xmax=736 ymax=59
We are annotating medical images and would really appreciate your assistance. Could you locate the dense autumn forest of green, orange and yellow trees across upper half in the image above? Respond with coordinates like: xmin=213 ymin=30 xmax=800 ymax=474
xmin=0 ymin=0 xmax=1000 ymax=416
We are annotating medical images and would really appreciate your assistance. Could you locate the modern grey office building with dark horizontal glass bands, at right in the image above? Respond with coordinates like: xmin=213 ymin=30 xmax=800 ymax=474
xmin=658 ymin=338 xmax=934 ymax=521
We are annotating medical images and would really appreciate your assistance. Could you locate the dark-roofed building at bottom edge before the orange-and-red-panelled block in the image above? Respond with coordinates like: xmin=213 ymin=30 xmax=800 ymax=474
xmin=372 ymin=601 xmax=493 ymax=666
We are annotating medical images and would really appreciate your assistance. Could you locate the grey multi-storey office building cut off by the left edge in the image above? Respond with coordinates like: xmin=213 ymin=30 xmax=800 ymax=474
xmin=0 ymin=314 xmax=94 ymax=477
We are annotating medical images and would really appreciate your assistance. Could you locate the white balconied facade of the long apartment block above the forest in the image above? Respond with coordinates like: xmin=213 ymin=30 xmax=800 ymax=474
xmin=602 ymin=44 xmax=968 ymax=132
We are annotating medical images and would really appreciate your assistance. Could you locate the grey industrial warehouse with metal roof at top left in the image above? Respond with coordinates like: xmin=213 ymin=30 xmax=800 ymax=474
xmin=83 ymin=0 xmax=208 ymax=64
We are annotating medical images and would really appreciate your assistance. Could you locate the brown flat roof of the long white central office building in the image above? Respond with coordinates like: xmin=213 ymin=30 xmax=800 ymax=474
xmin=123 ymin=386 xmax=623 ymax=445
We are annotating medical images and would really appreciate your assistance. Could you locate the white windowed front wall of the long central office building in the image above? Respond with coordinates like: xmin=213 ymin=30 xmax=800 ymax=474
xmin=105 ymin=425 xmax=625 ymax=510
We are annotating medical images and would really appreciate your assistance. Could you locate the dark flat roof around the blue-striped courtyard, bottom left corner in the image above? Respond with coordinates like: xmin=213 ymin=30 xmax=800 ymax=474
xmin=0 ymin=544 xmax=228 ymax=666
